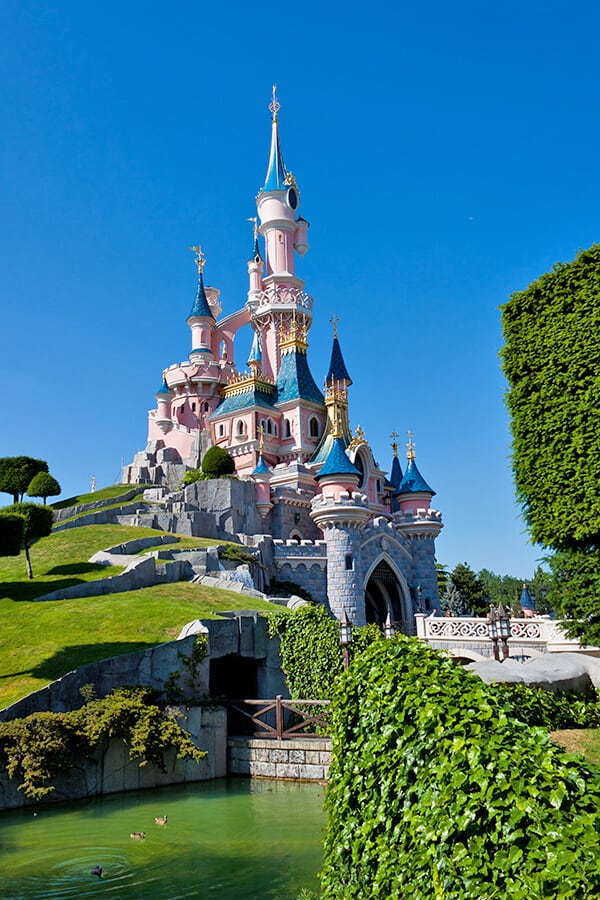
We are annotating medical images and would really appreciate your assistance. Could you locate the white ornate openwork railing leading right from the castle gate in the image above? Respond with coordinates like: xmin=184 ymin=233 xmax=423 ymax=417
xmin=415 ymin=613 xmax=594 ymax=652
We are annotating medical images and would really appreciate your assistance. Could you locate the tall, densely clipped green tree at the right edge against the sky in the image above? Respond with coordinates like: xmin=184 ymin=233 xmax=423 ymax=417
xmin=502 ymin=244 xmax=600 ymax=640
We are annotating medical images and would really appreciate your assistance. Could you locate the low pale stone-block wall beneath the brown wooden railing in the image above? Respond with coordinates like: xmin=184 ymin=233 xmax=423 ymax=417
xmin=227 ymin=736 xmax=331 ymax=781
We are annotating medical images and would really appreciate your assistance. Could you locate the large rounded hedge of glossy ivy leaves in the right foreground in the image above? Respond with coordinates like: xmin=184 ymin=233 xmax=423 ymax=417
xmin=322 ymin=636 xmax=600 ymax=900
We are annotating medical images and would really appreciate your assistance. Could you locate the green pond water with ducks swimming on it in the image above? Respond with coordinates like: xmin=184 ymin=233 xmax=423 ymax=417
xmin=0 ymin=778 xmax=325 ymax=900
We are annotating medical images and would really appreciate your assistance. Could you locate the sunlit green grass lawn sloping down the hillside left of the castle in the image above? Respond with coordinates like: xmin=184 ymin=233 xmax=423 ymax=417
xmin=0 ymin=525 xmax=281 ymax=708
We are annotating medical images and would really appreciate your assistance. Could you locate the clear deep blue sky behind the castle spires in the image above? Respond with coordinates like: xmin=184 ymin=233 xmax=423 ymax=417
xmin=0 ymin=0 xmax=600 ymax=577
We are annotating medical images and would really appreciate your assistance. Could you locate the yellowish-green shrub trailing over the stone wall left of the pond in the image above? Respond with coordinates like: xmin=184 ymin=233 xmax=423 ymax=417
xmin=0 ymin=688 xmax=206 ymax=800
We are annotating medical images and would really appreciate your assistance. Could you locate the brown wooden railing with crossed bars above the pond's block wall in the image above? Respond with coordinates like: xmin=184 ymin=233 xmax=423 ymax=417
xmin=226 ymin=694 xmax=330 ymax=740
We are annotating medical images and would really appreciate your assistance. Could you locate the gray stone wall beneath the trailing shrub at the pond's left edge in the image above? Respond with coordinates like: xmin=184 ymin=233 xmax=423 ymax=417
xmin=0 ymin=706 xmax=227 ymax=812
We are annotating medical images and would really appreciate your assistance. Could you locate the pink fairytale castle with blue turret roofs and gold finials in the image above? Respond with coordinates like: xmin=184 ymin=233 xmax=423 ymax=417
xmin=124 ymin=88 xmax=442 ymax=633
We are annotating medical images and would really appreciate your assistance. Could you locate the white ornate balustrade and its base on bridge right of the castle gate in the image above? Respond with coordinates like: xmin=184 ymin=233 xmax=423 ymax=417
xmin=415 ymin=613 xmax=600 ymax=660
